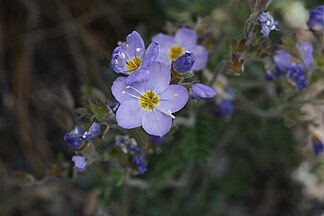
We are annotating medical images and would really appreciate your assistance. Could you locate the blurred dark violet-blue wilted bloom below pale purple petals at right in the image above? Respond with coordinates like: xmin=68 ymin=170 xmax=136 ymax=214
xmin=286 ymin=65 xmax=307 ymax=89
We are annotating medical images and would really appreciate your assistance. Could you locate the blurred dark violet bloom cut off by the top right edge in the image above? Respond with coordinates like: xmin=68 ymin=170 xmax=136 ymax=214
xmin=307 ymin=5 xmax=324 ymax=31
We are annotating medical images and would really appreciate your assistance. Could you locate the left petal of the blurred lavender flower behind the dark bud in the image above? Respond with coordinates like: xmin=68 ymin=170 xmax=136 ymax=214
xmin=152 ymin=33 xmax=176 ymax=65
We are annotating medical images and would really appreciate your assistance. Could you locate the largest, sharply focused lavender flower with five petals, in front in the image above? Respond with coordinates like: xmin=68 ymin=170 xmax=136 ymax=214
xmin=111 ymin=62 xmax=189 ymax=136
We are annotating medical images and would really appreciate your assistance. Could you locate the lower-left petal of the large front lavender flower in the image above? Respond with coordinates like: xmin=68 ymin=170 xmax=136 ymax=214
xmin=116 ymin=100 xmax=145 ymax=129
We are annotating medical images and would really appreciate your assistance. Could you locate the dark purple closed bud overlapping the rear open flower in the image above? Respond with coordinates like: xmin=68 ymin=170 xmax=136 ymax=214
xmin=173 ymin=51 xmax=196 ymax=74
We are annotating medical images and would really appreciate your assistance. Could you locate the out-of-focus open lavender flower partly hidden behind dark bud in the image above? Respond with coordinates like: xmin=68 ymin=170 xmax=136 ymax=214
xmin=152 ymin=28 xmax=208 ymax=72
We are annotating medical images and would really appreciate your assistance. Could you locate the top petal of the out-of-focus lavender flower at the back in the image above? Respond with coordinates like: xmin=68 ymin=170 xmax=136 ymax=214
xmin=174 ymin=28 xmax=197 ymax=51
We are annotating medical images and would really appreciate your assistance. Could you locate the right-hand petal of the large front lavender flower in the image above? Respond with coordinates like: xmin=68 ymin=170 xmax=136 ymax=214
xmin=157 ymin=85 xmax=189 ymax=113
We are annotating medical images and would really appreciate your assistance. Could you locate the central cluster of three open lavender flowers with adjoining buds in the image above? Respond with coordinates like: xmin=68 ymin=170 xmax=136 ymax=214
xmin=110 ymin=28 xmax=216 ymax=137
